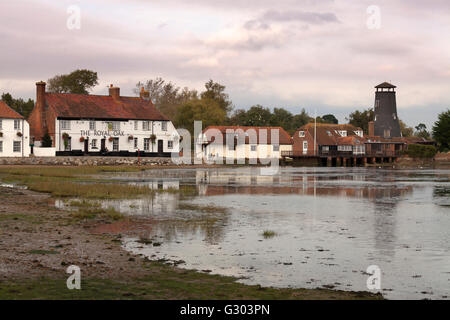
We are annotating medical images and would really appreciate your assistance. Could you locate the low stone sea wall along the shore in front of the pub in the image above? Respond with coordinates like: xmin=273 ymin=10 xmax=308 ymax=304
xmin=0 ymin=157 xmax=173 ymax=166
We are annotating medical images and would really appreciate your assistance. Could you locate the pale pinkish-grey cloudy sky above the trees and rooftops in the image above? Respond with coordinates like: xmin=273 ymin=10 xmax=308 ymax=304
xmin=0 ymin=0 xmax=450 ymax=126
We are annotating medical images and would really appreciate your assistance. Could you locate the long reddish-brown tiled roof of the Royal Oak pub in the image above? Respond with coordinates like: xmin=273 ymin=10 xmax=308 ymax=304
xmin=45 ymin=93 xmax=169 ymax=120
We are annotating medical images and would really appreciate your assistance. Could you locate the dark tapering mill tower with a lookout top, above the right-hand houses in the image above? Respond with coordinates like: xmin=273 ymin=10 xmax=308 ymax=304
xmin=374 ymin=82 xmax=402 ymax=138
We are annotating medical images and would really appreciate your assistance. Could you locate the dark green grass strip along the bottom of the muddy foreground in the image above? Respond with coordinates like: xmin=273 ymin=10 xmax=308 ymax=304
xmin=0 ymin=261 xmax=382 ymax=300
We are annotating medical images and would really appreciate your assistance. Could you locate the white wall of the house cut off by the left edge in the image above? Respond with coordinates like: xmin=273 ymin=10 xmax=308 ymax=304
xmin=0 ymin=118 xmax=31 ymax=157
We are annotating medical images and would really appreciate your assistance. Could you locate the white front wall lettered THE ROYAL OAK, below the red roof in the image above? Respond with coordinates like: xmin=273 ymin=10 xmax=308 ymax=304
xmin=55 ymin=119 xmax=179 ymax=152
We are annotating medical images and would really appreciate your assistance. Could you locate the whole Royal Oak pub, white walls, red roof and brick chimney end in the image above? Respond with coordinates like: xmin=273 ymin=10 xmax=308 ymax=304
xmin=29 ymin=82 xmax=179 ymax=157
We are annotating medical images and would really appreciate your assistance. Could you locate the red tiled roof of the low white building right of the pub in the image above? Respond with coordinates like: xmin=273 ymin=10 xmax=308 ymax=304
xmin=203 ymin=126 xmax=292 ymax=144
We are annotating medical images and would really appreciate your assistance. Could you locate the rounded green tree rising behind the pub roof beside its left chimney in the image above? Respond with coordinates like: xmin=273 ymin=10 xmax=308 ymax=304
xmin=47 ymin=69 xmax=98 ymax=94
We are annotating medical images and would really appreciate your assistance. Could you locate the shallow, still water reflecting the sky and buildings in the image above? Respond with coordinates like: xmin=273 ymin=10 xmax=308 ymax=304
xmin=67 ymin=167 xmax=450 ymax=299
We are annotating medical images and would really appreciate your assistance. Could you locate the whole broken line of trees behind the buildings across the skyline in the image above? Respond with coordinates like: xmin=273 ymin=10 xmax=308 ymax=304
xmin=2 ymin=69 xmax=450 ymax=151
